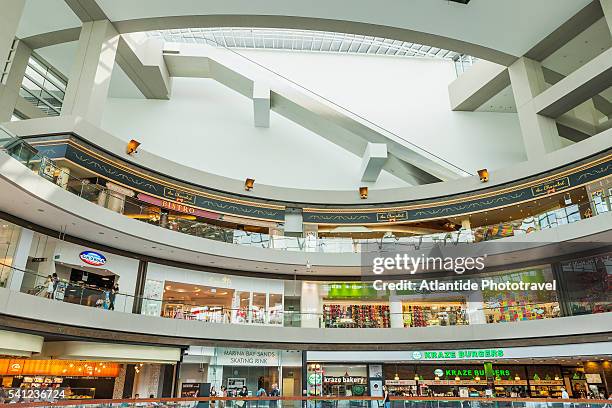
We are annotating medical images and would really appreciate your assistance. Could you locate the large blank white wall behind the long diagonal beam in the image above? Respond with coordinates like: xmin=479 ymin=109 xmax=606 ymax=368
xmin=102 ymin=51 xmax=525 ymax=190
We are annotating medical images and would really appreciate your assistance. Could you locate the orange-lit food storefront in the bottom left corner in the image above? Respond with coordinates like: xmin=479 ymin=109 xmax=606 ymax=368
xmin=0 ymin=359 xmax=120 ymax=399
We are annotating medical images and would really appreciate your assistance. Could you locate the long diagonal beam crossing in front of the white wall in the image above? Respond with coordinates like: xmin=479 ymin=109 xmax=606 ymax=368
xmin=164 ymin=44 xmax=467 ymax=185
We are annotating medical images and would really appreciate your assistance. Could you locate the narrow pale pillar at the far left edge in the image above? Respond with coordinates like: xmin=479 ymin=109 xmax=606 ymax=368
xmin=0 ymin=40 xmax=32 ymax=122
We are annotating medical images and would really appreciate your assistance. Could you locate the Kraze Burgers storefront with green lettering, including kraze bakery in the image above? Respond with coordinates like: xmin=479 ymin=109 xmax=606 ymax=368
xmin=304 ymin=342 xmax=612 ymax=398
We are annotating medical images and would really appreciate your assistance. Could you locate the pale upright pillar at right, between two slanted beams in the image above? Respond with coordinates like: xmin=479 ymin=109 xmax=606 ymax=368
xmin=508 ymin=57 xmax=563 ymax=160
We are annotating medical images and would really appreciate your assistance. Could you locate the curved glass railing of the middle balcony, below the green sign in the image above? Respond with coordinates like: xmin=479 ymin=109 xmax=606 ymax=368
xmin=0 ymin=263 xmax=612 ymax=329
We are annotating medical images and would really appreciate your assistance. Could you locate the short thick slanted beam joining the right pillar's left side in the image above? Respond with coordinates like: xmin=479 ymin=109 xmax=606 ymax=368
xmin=448 ymin=60 xmax=510 ymax=111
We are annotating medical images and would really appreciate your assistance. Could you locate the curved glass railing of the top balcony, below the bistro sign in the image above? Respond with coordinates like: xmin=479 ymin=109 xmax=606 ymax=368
xmin=0 ymin=129 xmax=612 ymax=253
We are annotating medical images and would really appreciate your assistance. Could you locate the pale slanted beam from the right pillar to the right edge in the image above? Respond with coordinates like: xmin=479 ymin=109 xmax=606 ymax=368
xmin=534 ymin=48 xmax=612 ymax=118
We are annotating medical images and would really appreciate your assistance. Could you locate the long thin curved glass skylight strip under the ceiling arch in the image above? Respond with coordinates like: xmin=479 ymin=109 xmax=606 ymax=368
xmin=147 ymin=27 xmax=474 ymax=60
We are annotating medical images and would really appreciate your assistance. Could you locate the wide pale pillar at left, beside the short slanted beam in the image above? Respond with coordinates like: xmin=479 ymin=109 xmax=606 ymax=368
xmin=62 ymin=20 xmax=119 ymax=125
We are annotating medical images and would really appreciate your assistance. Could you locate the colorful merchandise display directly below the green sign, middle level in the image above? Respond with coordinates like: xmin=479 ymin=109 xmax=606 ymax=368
xmin=323 ymin=304 xmax=391 ymax=328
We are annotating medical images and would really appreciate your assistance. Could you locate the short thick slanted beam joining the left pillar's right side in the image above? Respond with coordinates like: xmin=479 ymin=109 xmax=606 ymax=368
xmin=117 ymin=33 xmax=172 ymax=100
